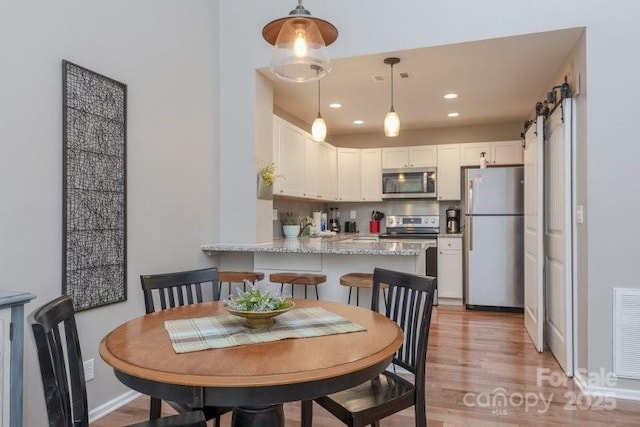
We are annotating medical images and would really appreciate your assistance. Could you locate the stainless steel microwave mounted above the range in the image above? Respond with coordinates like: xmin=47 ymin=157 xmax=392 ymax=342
xmin=382 ymin=168 xmax=436 ymax=199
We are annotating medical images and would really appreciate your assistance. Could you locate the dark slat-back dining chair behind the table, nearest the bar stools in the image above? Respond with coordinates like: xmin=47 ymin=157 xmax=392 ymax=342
xmin=140 ymin=268 xmax=233 ymax=426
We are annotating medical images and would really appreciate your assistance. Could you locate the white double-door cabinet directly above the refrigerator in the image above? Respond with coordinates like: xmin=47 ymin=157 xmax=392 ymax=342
xmin=460 ymin=140 xmax=524 ymax=167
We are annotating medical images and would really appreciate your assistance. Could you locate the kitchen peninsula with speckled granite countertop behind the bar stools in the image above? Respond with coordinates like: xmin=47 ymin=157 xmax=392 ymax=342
xmin=201 ymin=234 xmax=427 ymax=306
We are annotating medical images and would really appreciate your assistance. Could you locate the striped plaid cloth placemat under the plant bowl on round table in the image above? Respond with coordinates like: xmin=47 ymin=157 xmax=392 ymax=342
xmin=164 ymin=307 xmax=366 ymax=353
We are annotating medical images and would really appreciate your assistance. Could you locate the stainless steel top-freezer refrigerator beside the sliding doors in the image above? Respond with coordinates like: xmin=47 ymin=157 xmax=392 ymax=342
xmin=464 ymin=166 xmax=524 ymax=309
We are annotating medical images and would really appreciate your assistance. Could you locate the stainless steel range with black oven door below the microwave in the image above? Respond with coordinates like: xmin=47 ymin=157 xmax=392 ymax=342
xmin=379 ymin=215 xmax=440 ymax=305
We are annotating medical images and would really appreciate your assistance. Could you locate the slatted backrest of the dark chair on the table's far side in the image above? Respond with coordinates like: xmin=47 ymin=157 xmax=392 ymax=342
xmin=140 ymin=268 xmax=220 ymax=313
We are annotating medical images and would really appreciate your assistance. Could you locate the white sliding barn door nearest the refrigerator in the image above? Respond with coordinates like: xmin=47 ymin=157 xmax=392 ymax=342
xmin=524 ymin=116 xmax=544 ymax=352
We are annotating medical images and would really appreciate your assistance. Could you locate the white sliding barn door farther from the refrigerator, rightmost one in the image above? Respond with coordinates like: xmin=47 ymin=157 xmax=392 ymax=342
xmin=544 ymin=99 xmax=573 ymax=376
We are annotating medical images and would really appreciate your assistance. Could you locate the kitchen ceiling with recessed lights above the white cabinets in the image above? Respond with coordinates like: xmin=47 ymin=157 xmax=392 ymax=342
xmin=259 ymin=28 xmax=584 ymax=135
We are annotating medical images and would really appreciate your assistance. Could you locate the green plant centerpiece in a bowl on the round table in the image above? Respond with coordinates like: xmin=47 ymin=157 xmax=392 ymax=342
xmin=224 ymin=281 xmax=295 ymax=329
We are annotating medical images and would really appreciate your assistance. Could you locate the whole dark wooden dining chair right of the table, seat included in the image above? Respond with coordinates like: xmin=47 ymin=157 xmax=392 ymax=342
xmin=302 ymin=268 xmax=436 ymax=427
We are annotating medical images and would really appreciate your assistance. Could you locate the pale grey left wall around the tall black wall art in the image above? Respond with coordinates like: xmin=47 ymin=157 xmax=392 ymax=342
xmin=0 ymin=0 xmax=218 ymax=426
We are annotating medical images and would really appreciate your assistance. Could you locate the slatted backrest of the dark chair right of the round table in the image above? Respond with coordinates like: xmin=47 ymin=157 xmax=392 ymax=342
xmin=371 ymin=268 xmax=437 ymax=381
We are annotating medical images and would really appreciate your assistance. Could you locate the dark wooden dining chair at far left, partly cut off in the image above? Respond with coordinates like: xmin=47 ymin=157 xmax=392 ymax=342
xmin=28 ymin=295 xmax=207 ymax=427
